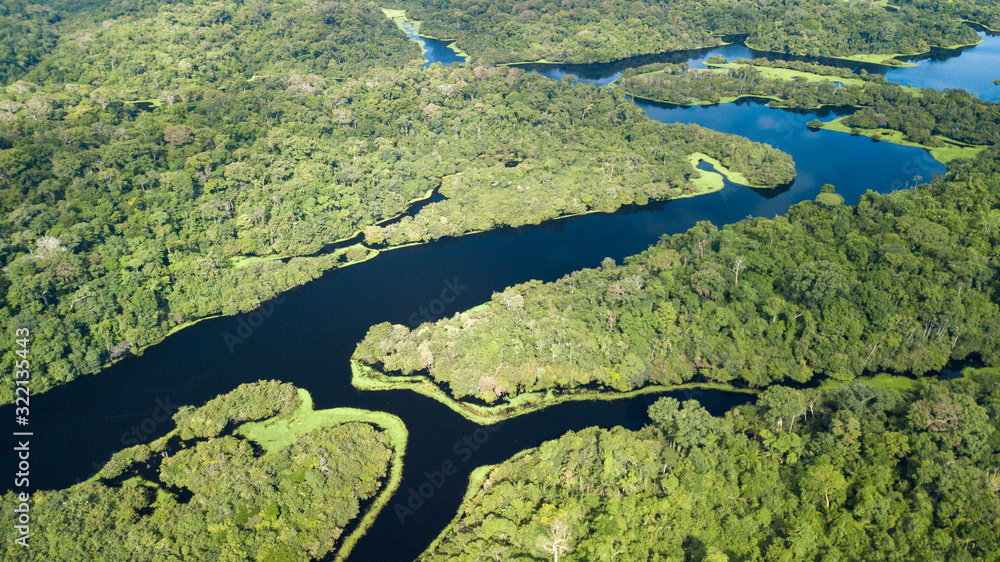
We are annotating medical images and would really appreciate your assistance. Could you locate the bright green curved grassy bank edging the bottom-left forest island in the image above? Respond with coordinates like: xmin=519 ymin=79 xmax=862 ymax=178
xmin=235 ymin=388 xmax=409 ymax=561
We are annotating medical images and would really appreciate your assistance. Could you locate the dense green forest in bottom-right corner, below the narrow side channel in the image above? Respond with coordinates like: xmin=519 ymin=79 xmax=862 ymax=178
xmin=420 ymin=374 xmax=1000 ymax=562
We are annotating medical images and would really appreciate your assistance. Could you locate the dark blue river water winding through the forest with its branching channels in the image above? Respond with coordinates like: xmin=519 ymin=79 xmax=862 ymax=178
xmin=0 ymin=20 xmax=1000 ymax=560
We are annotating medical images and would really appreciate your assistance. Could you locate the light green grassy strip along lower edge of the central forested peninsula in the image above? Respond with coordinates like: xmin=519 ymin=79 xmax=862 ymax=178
xmin=351 ymin=359 xmax=755 ymax=425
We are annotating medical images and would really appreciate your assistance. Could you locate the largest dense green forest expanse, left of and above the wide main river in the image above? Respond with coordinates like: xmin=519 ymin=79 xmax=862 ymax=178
xmin=0 ymin=0 xmax=794 ymax=403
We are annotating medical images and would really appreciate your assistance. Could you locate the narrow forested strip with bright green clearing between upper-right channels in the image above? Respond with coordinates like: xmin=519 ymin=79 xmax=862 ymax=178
xmin=618 ymin=58 xmax=1000 ymax=146
